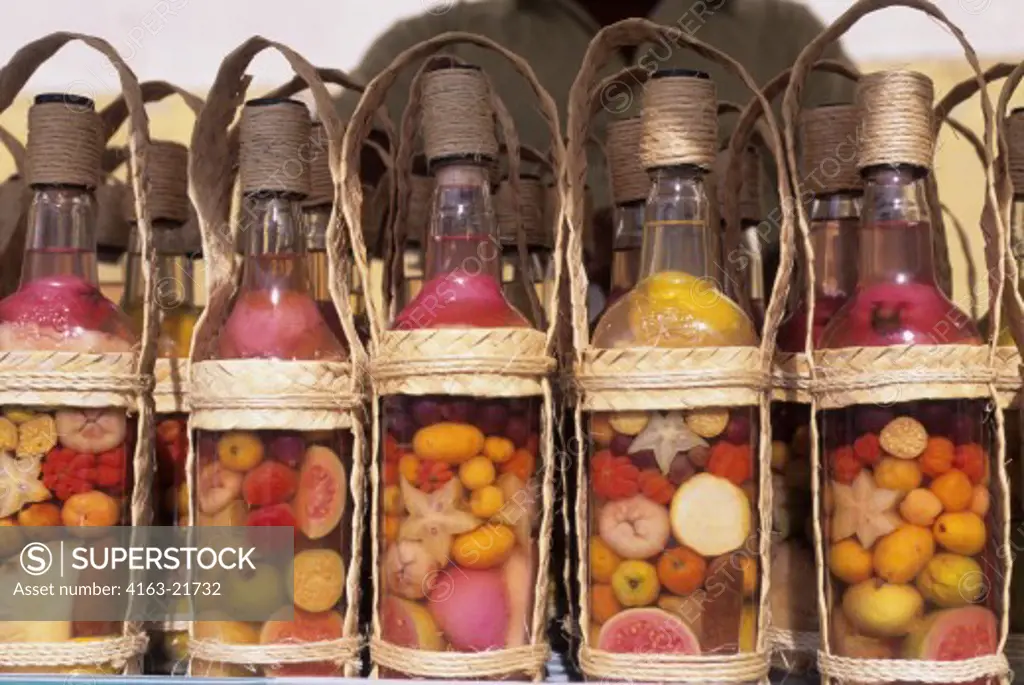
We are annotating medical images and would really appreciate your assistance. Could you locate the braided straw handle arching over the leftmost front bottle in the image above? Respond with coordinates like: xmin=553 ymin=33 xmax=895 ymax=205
xmin=0 ymin=32 xmax=159 ymax=668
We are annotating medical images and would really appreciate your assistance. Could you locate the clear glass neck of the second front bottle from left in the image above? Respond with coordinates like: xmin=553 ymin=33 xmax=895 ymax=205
xmin=239 ymin=192 xmax=309 ymax=293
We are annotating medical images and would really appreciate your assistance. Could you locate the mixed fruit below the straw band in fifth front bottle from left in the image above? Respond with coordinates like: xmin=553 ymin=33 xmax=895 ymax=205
xmin=821 ymin=400 xmax=1004 ymax=660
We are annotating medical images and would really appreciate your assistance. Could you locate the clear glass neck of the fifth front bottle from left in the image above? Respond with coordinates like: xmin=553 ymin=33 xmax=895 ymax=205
xmin=857 ymin=166 xmax=937 ymax=287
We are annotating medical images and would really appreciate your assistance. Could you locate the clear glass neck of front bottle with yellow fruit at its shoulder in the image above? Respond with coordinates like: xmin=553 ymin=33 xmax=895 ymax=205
xmin=640 ymin=167 xmax=714 ymax=280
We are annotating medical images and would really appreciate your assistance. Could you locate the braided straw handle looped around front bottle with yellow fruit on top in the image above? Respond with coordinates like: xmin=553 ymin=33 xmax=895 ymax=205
xmin=564 ymin=18 xmax=793 ymax=680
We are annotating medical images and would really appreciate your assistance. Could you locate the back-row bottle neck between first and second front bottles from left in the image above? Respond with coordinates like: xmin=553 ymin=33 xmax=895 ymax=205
xmin=121 ymin=219 xmax=196 ymax=310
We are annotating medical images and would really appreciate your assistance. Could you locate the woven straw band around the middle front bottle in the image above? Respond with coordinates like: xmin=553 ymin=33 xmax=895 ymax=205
xmin=371 ymin=329 xmax=555 ymax=397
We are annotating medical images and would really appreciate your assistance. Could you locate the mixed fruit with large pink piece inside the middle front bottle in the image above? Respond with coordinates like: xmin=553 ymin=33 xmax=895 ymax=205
xmin=378 ymin=395 xmax=542 ymax=677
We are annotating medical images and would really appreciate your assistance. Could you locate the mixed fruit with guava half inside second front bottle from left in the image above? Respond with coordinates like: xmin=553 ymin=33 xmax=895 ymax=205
xmin=193 ymin=423 xmax=352 ymax=677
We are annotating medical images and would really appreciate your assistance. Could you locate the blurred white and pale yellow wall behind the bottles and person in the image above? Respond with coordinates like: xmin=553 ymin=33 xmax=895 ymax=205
xmin=0 ymin=0 xmax=1024 ymax=309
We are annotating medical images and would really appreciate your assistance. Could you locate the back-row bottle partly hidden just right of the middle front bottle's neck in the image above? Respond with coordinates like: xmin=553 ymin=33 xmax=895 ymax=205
xmin=497 ymin=174 xmax=551 ymax=329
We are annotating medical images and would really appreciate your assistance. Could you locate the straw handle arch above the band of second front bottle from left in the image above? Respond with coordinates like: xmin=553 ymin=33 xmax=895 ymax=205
xmin=188 ymin=36 xmax=370 ymax=368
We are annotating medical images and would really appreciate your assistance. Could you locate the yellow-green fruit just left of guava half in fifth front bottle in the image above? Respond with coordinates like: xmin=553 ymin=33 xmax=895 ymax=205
xmin=843 ymin=579 xmax=925 ymax=638
